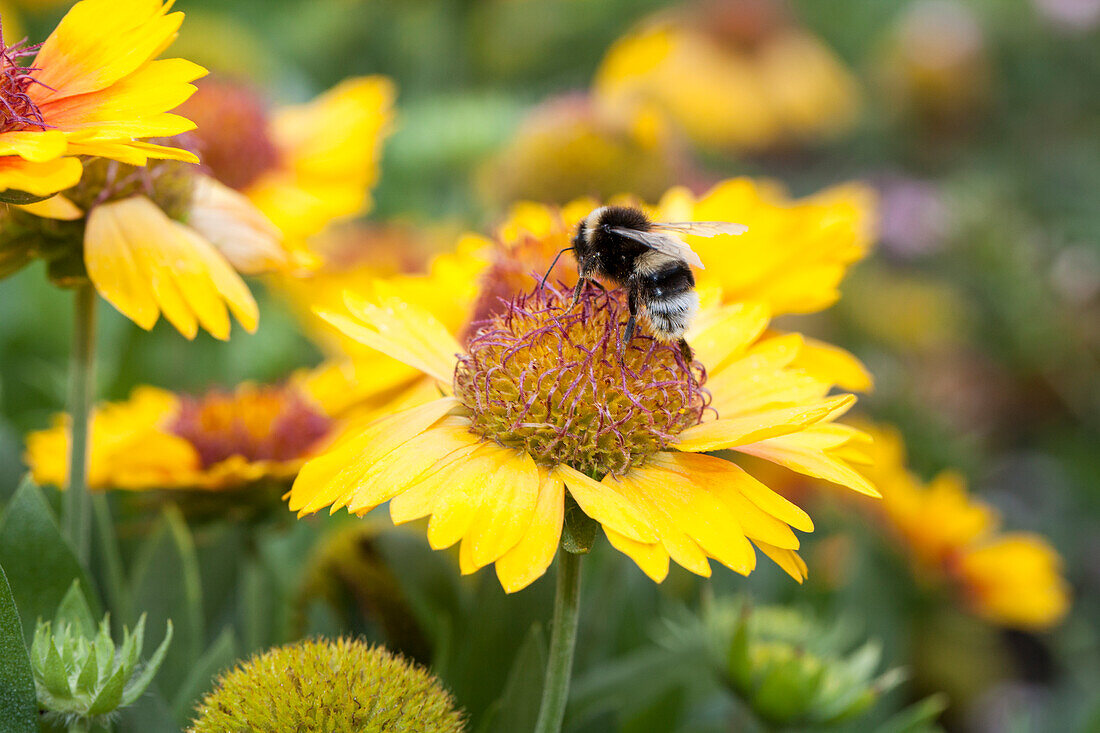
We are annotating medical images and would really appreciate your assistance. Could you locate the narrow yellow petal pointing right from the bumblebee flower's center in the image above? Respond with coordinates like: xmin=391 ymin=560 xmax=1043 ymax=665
xmin=672 ymin=394 xmax=856 ymax=453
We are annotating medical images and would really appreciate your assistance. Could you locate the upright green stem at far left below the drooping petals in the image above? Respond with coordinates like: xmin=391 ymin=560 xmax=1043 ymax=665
xmin=62 ymin=283 xmax=96 ymax=562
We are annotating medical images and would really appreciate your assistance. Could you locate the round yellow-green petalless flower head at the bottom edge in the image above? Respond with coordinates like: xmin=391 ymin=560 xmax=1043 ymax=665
xmin=189 ymin=638 xmax=464 ymax=733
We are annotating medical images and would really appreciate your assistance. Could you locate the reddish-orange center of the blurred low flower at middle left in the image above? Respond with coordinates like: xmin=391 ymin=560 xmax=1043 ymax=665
xmin=168 ymin=384 xmax=332 ymax=468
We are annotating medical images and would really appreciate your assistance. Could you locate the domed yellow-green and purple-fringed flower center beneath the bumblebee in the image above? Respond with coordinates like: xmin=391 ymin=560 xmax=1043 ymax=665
xmin=454 ymin=285 xmax=710 ymax=477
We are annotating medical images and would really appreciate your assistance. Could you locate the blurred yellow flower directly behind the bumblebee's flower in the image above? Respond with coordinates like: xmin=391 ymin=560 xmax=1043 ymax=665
xmin=297 ymin=178 xmax=875 ymax=416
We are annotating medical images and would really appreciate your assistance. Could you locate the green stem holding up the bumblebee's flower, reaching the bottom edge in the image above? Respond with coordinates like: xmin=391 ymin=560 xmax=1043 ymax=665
xmin=535 ymin=550 xmax=581 ymax=733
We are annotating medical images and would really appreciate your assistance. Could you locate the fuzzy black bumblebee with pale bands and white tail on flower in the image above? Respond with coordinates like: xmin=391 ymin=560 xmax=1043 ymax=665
xmin=543 ymin=206 xmax=747 ymax=362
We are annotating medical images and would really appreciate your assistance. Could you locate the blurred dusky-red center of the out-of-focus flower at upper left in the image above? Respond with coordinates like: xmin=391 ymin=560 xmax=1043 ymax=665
xmin=179 ymin=79 xmax=279 ymax=190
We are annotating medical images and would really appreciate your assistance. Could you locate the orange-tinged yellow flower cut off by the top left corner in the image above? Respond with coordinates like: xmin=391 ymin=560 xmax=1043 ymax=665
xmin=0 ymin=0 xmax=206 ymax=203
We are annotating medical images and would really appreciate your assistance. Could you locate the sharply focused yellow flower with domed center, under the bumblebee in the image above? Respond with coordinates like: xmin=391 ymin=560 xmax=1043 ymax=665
xmin=289 ymin=278 xmax=877 ymax=592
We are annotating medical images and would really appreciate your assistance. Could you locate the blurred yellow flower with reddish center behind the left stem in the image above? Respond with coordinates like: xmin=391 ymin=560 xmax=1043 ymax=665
xmin=24 ymin=373 xmax=338 ymax=491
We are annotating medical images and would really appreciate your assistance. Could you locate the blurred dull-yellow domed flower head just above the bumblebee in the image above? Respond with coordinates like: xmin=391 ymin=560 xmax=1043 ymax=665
xmin=481 ymin=95 xmax=684 ymax=204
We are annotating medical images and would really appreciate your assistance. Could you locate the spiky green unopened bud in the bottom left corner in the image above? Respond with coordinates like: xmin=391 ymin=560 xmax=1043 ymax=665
xmin=31 ymin=614 xmax=172 ymax=725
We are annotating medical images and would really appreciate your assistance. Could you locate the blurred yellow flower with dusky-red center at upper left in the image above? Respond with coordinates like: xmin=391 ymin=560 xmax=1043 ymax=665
xmin=184 ymin=76 xmax=395 ymax=245
